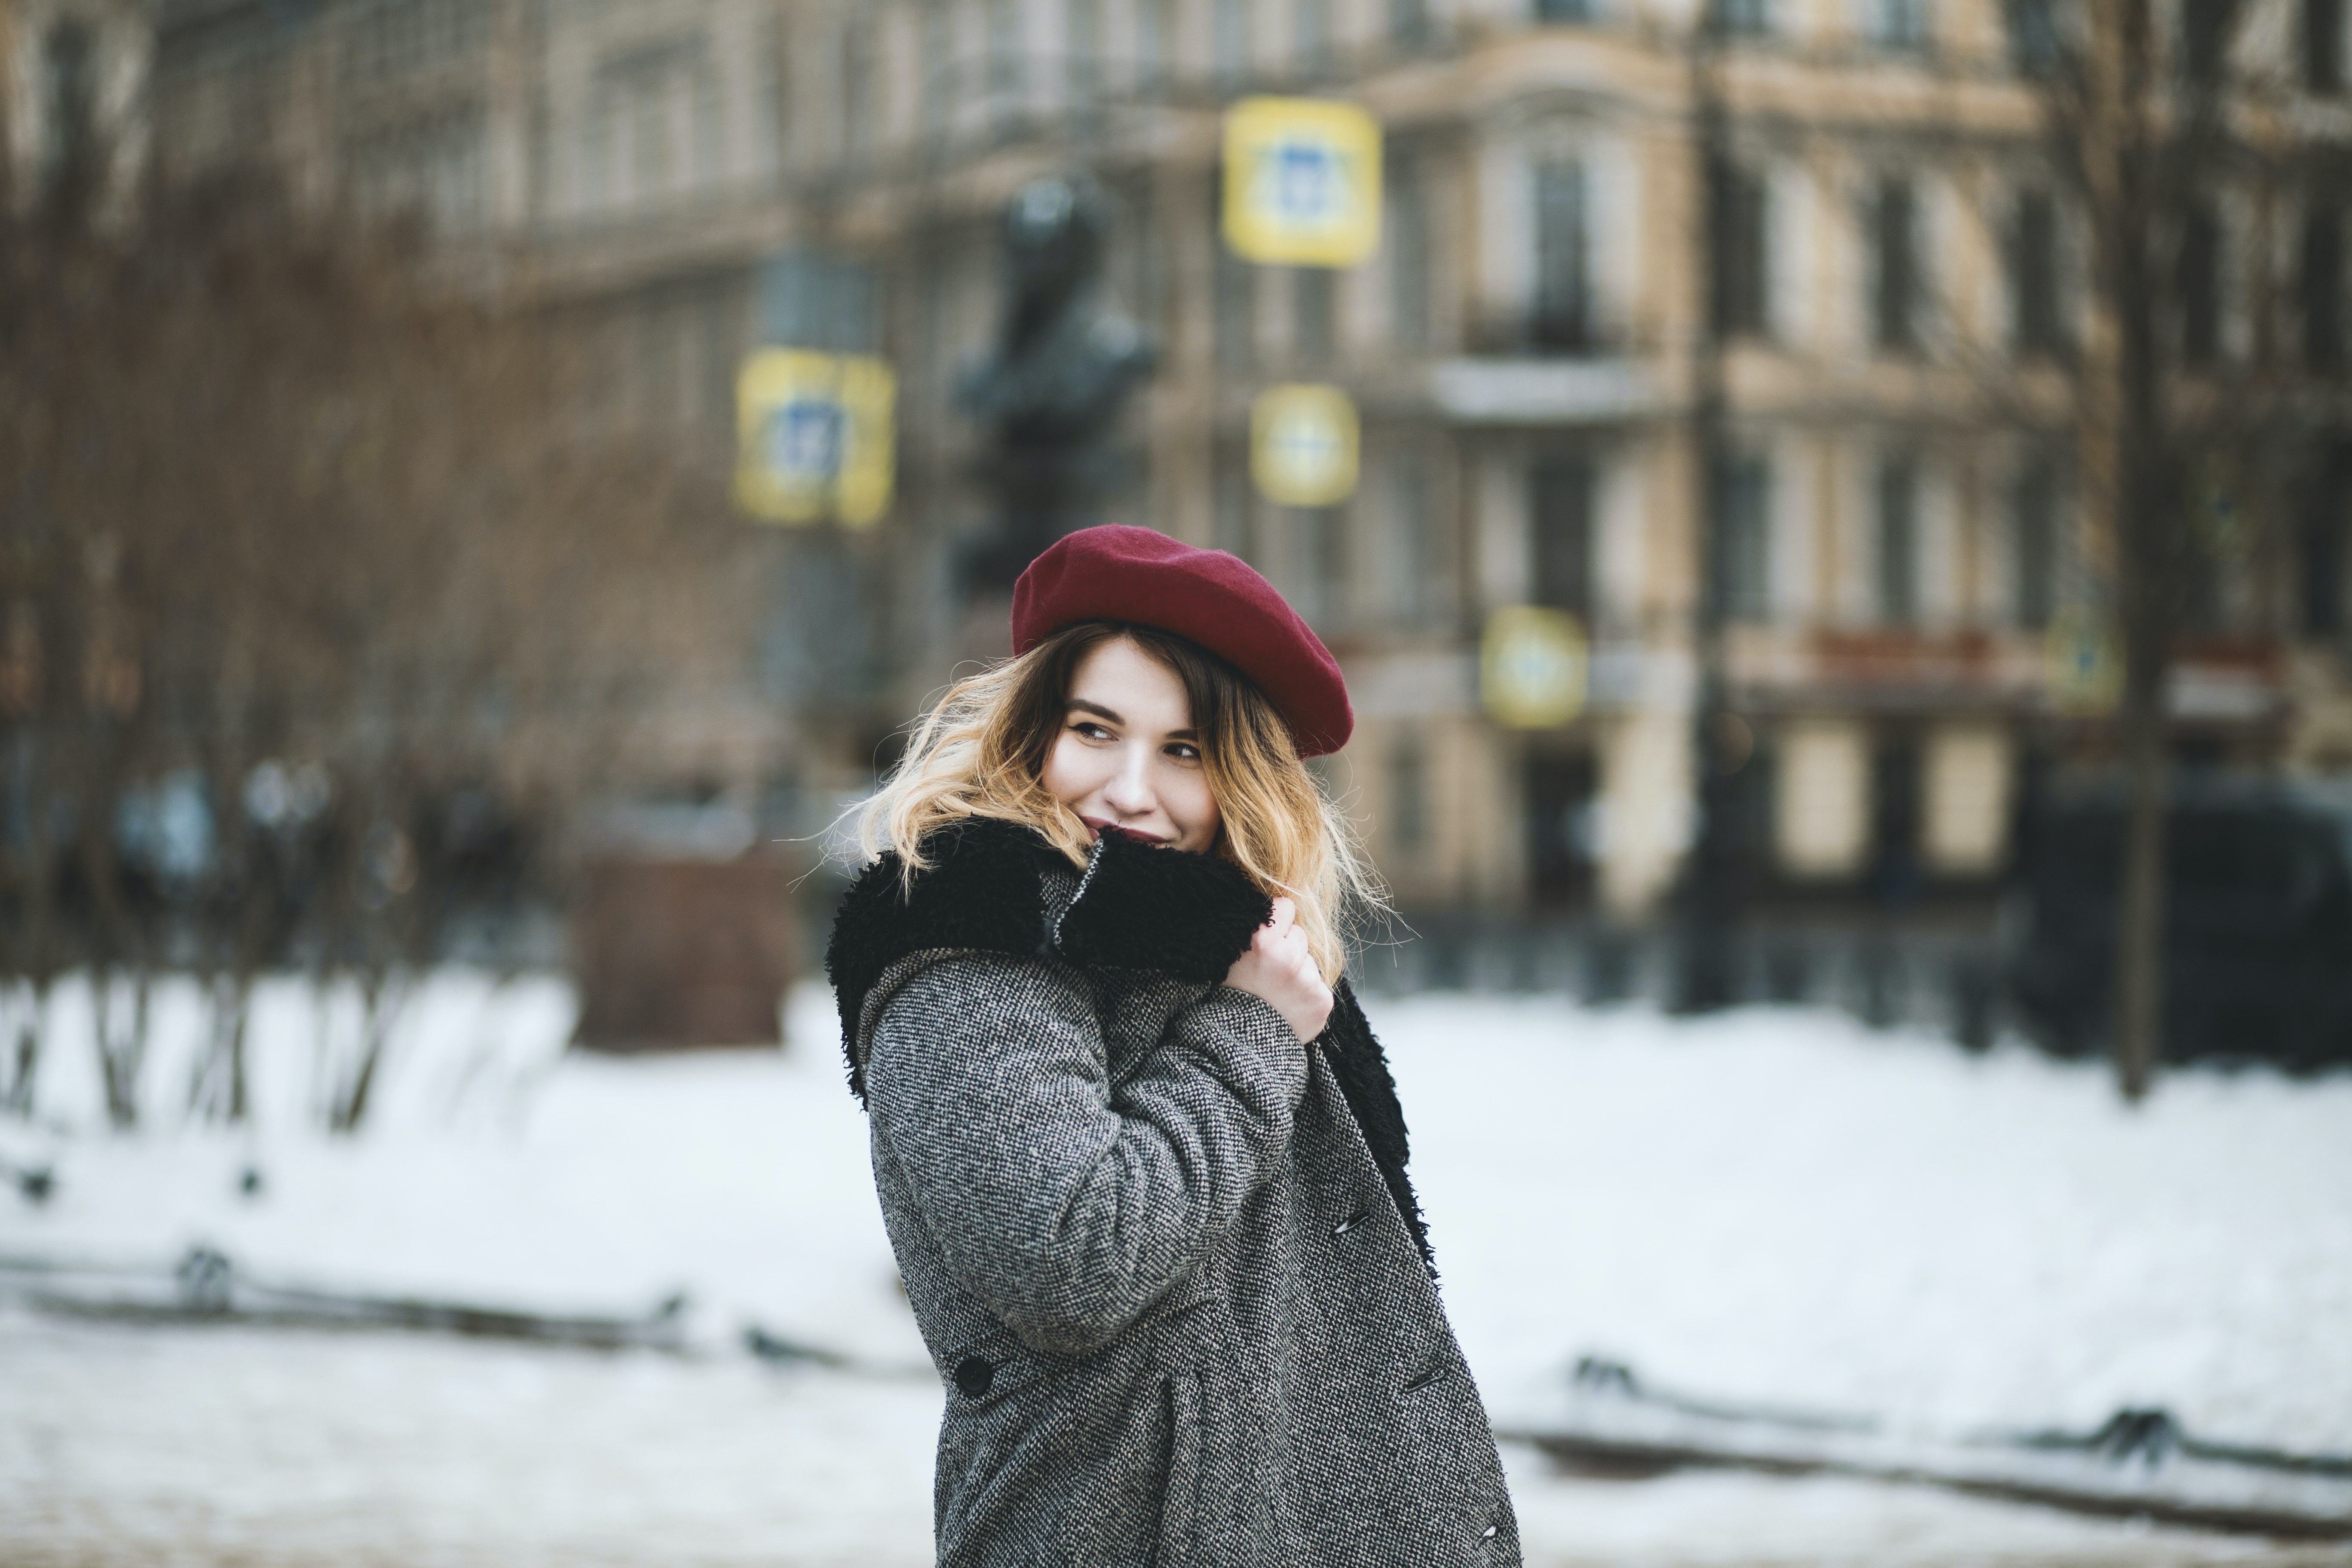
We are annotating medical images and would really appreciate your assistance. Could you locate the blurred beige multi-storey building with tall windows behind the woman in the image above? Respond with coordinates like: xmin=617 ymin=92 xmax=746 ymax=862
xmin=74 ymin=0 xmax=2352 ymax=959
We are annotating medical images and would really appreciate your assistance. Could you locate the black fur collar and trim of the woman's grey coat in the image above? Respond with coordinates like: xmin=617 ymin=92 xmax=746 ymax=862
xmin=826 ymin=818 xmax=1430 ymax=1258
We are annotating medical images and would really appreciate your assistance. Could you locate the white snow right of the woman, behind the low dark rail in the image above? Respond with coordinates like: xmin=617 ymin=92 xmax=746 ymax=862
xmin=1378 ymin=997 xmax=2352 ymax=1453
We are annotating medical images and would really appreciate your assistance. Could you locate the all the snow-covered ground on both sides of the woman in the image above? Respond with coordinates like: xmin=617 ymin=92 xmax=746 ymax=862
xmin=0 ymin=976 xmax=2352 ymax=1568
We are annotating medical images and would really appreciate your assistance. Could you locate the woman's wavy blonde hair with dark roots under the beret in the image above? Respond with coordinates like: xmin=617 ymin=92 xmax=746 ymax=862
xmin=856 ymin=621 xmax=1385 ymax=980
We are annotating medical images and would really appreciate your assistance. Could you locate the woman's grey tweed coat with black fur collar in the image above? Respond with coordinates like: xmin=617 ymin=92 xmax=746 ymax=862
xmin=826 ymin=823 xmax=1519 ymax=1568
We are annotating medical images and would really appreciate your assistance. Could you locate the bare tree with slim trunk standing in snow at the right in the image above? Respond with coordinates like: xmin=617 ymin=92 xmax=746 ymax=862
xmin=2018 ymin=0 xmax=2340 ymax=1100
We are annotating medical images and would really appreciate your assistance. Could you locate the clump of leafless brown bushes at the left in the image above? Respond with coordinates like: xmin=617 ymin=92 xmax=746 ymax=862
xmin=0 ymin=153 xmax=764 ymax=1131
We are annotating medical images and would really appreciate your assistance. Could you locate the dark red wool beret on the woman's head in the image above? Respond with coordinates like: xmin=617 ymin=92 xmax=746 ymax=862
xmin=1014 ymin=524 xmax=1355 ymax=757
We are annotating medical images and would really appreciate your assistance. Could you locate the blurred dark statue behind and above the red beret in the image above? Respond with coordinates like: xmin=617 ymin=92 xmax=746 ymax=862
xmin=957 ymin=174 xmax=1157 ymax=588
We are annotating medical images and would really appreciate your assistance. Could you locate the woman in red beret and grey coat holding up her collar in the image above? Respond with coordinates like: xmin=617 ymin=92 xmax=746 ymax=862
xmin=826 ymin=527 xmax=1519 ymax=1568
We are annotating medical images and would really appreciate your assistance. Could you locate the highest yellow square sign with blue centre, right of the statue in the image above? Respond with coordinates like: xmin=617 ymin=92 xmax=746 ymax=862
xmin=1225 ymin=99 xmax=1381 ymax=266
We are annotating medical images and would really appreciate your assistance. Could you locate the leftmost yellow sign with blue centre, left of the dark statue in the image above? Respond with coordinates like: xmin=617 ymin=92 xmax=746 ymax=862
xmin=736 ymin=348 xmax=898 ymax=529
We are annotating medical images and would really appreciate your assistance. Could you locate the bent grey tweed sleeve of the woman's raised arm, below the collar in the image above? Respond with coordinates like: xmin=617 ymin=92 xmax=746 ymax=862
xmin=866 ymin=952 xmax=1305 ymax=1357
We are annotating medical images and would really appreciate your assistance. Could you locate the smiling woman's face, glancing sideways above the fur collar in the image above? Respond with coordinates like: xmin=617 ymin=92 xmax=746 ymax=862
xmin=1040 ymin=637 xmax=1218 ymax=853
